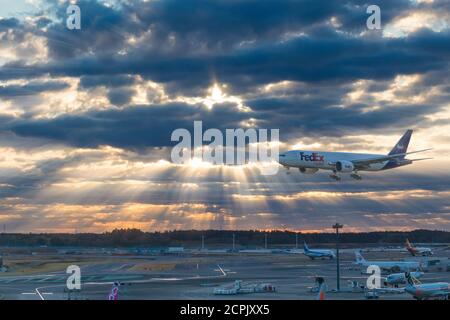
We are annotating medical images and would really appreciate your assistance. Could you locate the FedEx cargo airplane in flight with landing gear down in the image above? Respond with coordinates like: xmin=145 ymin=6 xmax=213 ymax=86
xmin=278 ymin=130 xmax=430 ymax=181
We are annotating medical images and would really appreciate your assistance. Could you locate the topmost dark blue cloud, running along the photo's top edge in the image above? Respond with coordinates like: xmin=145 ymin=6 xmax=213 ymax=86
xmin=43 ymin=0 xmax=413 ymax=58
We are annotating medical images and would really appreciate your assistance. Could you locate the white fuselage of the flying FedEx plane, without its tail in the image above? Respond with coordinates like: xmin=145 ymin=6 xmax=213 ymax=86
xmin=279 ymin=150 xmax=388 ymax=171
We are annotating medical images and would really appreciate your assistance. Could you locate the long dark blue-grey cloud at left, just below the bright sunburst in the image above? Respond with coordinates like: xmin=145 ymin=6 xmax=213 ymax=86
xmin=0 ymin=104 xmax=246 ymax=149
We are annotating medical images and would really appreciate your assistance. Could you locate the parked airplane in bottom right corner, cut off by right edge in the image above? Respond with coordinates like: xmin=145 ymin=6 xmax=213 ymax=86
xmin=405 ymin=272 xmax=450 ymax=300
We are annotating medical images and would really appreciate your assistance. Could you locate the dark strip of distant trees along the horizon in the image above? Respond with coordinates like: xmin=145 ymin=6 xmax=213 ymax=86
xmin=0 ymin=229 xmax=450 ymax=247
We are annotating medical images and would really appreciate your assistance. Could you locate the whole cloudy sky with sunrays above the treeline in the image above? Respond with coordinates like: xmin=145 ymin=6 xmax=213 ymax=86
xmin=0 ymin=0 xmax=450 ymax=232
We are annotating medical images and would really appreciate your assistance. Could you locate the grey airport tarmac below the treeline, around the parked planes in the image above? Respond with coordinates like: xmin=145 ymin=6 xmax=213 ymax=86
xmin=0 ymin=250 xmax=450 ymax=300
